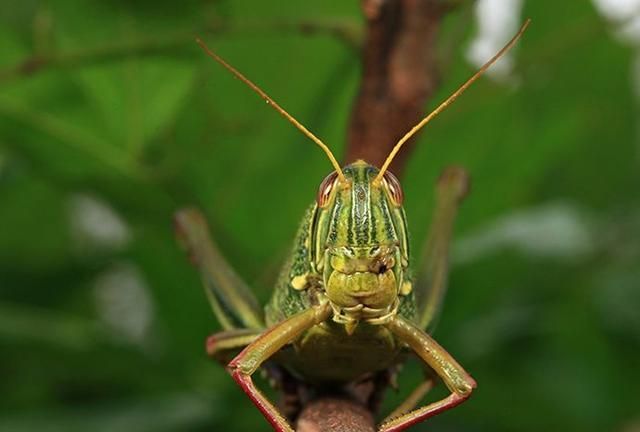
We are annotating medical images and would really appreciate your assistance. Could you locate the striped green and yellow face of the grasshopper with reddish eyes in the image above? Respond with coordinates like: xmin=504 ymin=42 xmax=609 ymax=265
xmin=311 ymin=161 xmax=408 ymax=330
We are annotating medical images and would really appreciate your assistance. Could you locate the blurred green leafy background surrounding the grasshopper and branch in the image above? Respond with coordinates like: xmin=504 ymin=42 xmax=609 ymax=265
xmin=0 ymin=0 xmax=640 ymax=432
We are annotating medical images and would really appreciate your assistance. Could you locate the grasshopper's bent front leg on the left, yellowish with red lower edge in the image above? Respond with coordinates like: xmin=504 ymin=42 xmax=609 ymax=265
xmin=227 ymin=303 xmax=331 ymax=432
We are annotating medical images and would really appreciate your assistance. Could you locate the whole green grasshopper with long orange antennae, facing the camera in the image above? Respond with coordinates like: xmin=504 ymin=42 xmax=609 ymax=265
xmin=175 ymin=20 xmax=529 ymax=432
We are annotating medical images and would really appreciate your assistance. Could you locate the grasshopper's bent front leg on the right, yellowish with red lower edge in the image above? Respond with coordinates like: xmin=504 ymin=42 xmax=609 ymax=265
xmin=379 ymin=316 xmax=476 ymax=432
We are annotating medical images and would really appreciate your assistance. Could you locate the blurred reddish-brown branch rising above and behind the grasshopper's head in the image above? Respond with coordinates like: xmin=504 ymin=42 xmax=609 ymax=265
xmin=345 ymin=0 xmax=452 ymax=174
